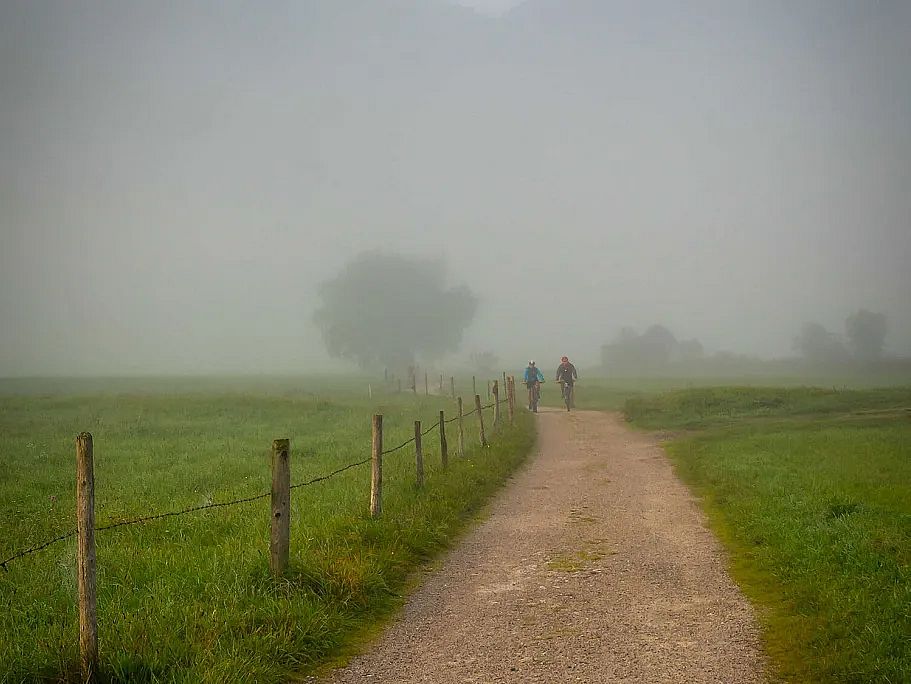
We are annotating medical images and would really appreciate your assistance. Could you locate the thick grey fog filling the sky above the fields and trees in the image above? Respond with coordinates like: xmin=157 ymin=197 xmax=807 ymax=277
xmin=0 ymin=0 xmax=911 ymax=376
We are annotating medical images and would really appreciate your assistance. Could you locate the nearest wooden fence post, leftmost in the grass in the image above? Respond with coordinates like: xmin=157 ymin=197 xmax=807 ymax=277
xmin=76 ymin=432 xmax=98 ymax=682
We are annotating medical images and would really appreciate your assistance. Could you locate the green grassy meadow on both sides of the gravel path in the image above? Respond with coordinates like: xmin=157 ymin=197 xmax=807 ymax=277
xmin=8 ymin=377 xmax=911 ymax=682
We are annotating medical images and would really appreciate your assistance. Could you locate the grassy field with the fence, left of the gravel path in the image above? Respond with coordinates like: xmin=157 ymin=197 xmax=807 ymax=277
xmin=0 ymin=378 xmax=534 ymax=682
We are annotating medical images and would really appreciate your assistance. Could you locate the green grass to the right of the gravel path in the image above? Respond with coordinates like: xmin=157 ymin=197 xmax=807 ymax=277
xmin=627 ymin=388 xmax=911 ymax=682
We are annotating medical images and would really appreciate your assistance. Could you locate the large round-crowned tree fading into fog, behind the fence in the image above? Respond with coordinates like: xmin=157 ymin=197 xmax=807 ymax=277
xmin=314 ymin=252 xmax=477 ymax=369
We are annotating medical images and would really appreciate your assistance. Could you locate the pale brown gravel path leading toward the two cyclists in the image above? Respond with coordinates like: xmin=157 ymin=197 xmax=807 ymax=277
xmin=326 ymin=411 xmax=764 ymax=684
